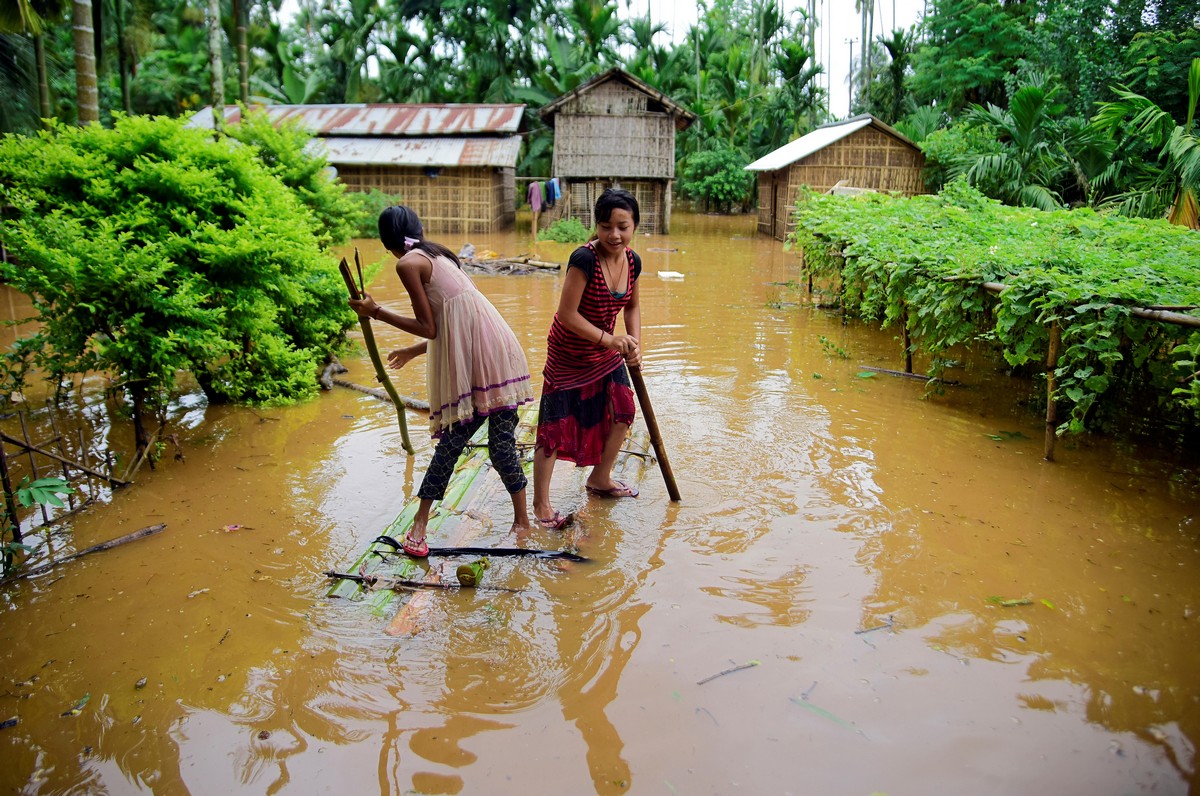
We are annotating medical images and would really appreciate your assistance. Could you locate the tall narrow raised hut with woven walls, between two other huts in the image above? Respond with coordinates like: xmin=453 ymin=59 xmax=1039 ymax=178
xmin=540 ymin=68 xmax=696 ymax=234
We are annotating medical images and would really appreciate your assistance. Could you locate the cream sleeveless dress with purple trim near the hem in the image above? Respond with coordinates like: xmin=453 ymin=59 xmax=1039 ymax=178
xmin=415 ymin=250 xmax=534 ymax=437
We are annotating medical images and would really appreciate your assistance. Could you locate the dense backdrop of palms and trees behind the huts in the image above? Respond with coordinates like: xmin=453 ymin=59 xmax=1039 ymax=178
xmin=0 ymin=0 xmax=1200 ymax=216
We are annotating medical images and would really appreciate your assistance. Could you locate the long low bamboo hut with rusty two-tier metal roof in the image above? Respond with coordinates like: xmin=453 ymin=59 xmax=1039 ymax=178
xmin=191 ymin=103 xmax=524 ymax=234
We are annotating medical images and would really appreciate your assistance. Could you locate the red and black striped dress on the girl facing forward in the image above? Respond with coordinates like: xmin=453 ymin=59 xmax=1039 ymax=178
xmin=538 ymin=244 xmax=642 ymax=467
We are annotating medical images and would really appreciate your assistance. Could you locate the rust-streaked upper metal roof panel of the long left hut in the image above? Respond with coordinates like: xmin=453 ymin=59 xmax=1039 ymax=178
xmin=188 ymin=103 xmax=524 ymax=136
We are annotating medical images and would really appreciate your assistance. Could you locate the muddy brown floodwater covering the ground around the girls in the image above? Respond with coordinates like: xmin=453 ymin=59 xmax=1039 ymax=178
xmin=0 ymin=215 xmax=1200 ymax=796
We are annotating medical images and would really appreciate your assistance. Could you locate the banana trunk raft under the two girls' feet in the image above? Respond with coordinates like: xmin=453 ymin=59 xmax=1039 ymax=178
xmin=326 ymin=405 xmax=655 ymax=635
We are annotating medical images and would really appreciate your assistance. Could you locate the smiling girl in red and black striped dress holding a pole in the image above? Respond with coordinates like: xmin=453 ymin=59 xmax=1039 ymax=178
xmin=533 ymin=188 xmax=642 ymax=528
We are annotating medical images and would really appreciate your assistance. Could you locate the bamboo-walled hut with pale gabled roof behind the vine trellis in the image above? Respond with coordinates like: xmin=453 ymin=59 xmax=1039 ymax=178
xmin=746 ymin=114 xmax=925 ymax=240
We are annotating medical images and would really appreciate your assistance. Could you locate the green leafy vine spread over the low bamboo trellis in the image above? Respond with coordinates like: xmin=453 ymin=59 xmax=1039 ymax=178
xmin=792 ymin=180 xmax=1200 ymax=432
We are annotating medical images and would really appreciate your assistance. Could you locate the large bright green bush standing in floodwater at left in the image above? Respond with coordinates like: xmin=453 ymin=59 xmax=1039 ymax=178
xmin=0 ymin=116 xmax=354 ymax=427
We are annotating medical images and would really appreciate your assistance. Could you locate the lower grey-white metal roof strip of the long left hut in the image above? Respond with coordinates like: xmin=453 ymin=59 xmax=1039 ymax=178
xmin=308 ymin=136 xmax=521 ymax=168
